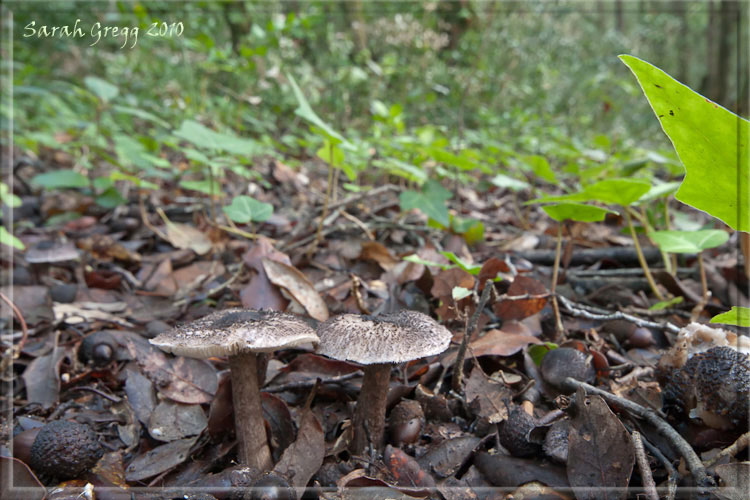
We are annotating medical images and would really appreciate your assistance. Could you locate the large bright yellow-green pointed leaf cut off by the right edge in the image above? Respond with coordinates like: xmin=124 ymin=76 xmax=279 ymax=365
xmin=620 ymin=55 xmax=750 ymax=232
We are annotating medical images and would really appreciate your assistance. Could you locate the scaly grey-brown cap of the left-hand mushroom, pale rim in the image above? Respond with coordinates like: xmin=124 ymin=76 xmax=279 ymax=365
xmin=150 ymin=309 xmax=318 ymax=358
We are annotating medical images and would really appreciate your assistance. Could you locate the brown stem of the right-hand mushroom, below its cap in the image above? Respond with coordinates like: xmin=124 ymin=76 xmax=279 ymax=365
xmin=351 ymin=363 xmax=393 ymax=455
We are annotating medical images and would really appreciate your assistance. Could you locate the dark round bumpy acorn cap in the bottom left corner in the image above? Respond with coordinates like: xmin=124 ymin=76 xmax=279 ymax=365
xmin=30 ymin=420 xmax=104 ymax=479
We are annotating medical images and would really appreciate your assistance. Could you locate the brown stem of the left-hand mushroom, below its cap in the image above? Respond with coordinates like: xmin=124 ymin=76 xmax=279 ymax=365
xmin=229 ymin=353 xmax=273 ymax=471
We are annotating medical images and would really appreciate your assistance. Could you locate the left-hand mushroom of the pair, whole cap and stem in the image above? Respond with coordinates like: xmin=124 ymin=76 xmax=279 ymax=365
xmin=150 ymin=309 xmax=318 ymax=471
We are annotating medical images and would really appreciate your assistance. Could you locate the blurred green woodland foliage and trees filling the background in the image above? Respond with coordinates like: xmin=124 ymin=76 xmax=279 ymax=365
xmin=3 ymin=0 xmax=748 ymax=197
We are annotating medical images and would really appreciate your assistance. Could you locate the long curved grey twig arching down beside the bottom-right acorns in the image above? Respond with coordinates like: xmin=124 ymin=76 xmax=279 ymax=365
xmin=565 ymin=377 xmax=716 ymax=488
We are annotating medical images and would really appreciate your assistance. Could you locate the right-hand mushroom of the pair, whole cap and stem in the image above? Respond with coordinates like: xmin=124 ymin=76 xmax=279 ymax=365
xmin=318 ymin=311 xmax=452 ymax=454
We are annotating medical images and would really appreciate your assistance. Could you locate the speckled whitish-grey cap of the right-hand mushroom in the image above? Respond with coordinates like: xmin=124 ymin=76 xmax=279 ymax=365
xmin=318 ymin=310 xmax=453 ymax=365
